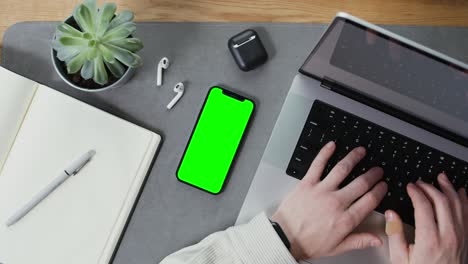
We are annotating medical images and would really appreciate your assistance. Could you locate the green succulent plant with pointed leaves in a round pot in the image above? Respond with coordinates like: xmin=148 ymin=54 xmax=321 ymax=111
xmin=52 ymin=0 xmax=143 ymax=85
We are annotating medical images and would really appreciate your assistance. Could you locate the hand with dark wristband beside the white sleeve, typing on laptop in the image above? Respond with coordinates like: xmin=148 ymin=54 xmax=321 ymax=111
xmin=271 ymin=142 xmax=387 ymax=261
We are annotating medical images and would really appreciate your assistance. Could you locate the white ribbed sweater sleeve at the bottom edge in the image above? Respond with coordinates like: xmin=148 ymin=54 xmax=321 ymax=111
xmin=160 ymin=213 xmax=297 ymax=264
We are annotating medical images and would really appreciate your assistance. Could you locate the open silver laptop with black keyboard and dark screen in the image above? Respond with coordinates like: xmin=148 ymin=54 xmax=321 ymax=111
xmin=237 ymin=13 xmax=468 ymax=264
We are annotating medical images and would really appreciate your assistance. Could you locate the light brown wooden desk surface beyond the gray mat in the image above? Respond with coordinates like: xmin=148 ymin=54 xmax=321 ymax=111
xmin=0 ymin=0 xmax=468 ymax=53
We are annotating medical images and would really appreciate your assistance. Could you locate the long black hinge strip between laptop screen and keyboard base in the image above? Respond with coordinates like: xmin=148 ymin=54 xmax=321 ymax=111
xmin=320 ymin=76 xmax=468 ymax=147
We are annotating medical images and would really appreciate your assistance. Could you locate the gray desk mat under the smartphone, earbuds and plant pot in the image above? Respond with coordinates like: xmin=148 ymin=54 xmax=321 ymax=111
xmin=3 ymin=22 xmax=468 ymax=264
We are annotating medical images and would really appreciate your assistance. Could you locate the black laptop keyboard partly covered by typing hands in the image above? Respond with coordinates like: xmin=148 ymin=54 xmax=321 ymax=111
xmin=286 ymin=100 xmax=468 ymax=226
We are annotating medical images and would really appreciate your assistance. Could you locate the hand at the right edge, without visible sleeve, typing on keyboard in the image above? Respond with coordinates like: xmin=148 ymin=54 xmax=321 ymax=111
xmin=385 ymin=174 xmax=468 ymax=264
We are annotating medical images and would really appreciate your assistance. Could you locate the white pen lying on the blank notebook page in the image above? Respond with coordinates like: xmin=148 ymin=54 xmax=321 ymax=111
xmin=6 ymin=150 xmax=96 ymax=226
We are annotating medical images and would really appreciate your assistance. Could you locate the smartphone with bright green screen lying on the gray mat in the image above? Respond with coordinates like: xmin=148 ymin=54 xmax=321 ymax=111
xmin=176 ymin=87 xmax=255 ymax=194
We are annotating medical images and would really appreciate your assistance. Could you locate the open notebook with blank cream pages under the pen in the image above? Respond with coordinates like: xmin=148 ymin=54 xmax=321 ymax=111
xmin=0 ymin=67 xmax=161 ymax=264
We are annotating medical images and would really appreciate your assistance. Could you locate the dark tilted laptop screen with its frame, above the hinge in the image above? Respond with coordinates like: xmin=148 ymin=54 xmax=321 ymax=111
xmin=301 ymin=17 xmax=468 ymax=138
